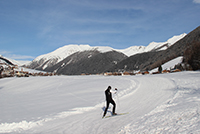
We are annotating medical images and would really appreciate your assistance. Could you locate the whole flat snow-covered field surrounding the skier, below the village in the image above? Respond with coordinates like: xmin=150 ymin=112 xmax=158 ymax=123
xmin=0 ymin=71 xmax=200 ymax=134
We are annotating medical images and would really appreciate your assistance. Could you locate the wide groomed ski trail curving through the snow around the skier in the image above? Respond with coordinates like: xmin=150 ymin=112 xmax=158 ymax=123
xmin=0 ymin=76 xmax=175 ymax=134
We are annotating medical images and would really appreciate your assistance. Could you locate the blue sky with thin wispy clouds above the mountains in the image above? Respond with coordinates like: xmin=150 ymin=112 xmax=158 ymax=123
xmin=0 ymin=0 xmax=200 ymax=60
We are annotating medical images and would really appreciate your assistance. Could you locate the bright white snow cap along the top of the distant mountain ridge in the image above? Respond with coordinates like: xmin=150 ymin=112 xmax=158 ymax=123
xmin=29 ymin=33 xmax=186 ymax=68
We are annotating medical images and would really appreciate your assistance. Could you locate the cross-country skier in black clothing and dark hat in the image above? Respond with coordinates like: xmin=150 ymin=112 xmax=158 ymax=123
xmin=103 ymin=86 xmax=117 ymax=117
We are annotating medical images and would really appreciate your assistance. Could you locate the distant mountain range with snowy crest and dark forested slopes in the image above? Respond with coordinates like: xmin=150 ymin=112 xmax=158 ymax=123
xmin=26 ymin=27 xmax=200 ymax=75
